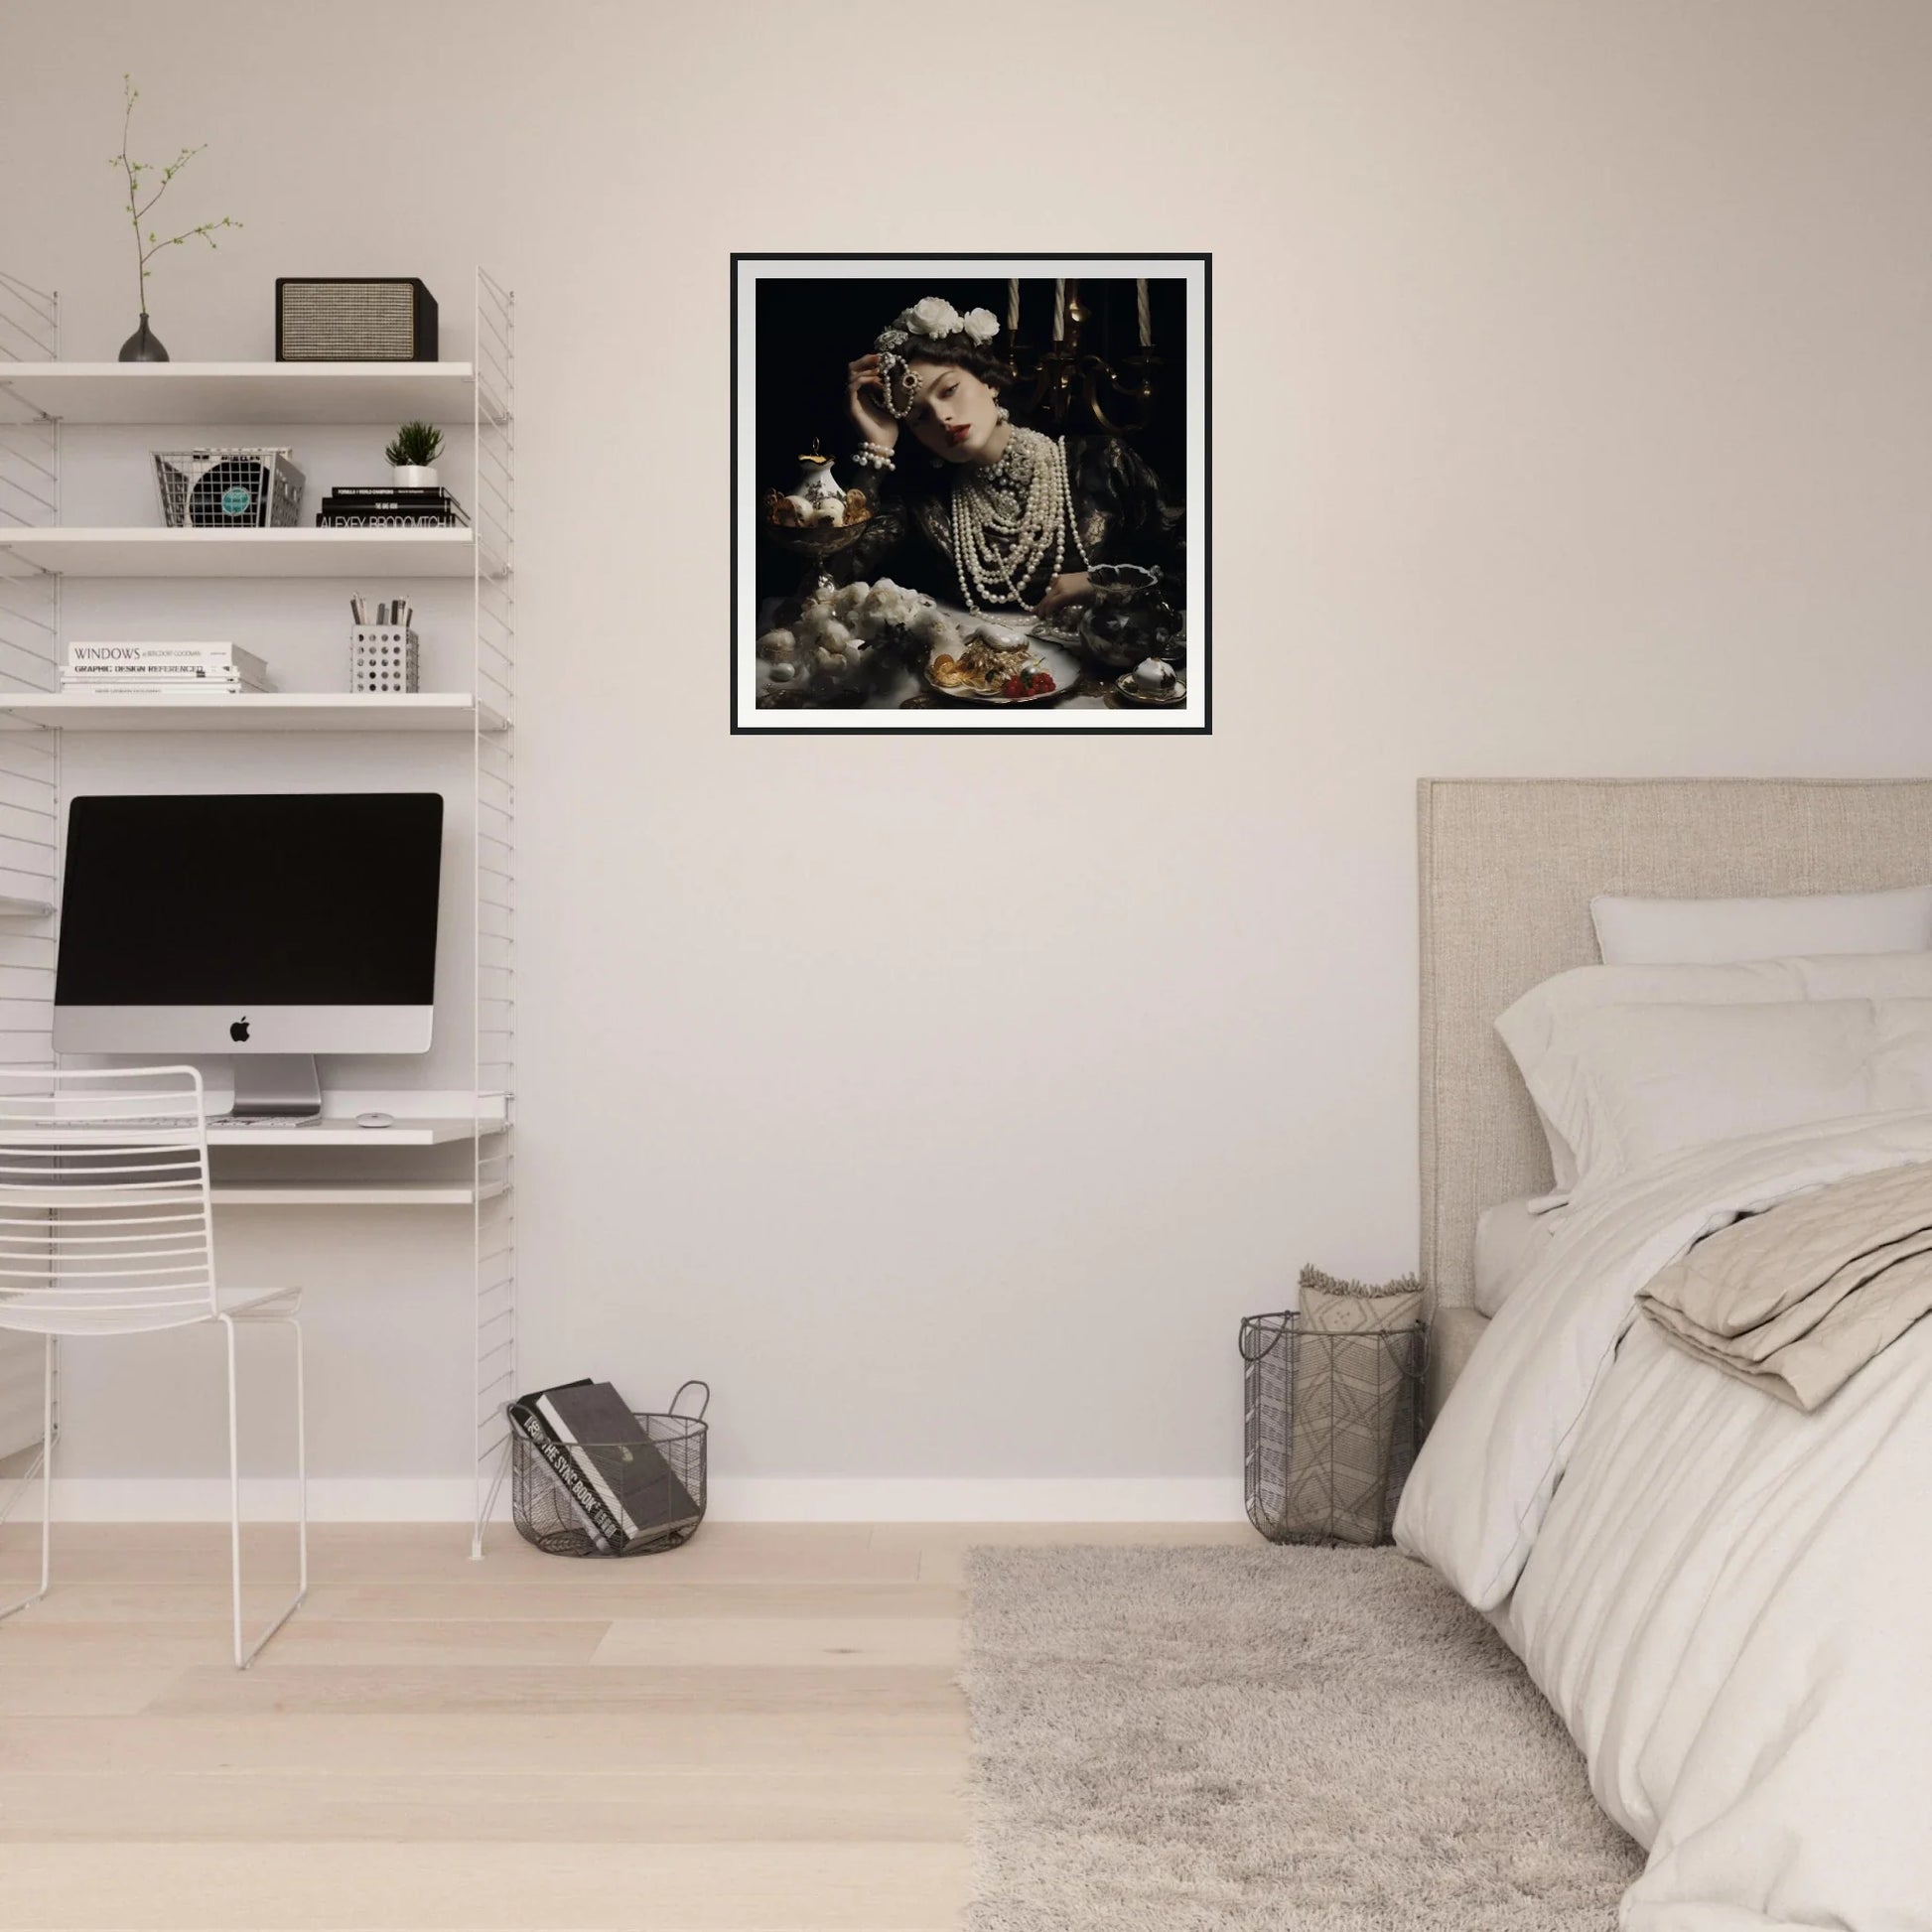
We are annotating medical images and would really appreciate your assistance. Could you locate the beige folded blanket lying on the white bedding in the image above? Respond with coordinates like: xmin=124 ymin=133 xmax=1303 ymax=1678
xmin=1638 ymin=1162 xmax=1932 ymax=1411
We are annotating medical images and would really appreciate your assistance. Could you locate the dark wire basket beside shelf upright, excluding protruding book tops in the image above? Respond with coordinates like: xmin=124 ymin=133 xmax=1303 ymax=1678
xmin=510 ymin=1381 xmax=711 ymax=1557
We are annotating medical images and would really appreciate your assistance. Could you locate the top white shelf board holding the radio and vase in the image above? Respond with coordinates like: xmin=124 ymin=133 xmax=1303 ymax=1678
xmin=0 ymin=361 xmax=474 ymax=425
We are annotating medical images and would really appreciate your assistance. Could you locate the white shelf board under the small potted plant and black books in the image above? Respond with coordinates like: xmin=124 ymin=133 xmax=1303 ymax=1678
xmin=0 ymin=525 xmax=476 ymax=578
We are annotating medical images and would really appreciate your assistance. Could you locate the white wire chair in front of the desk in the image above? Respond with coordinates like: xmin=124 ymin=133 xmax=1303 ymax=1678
xmin=0 ymin=1066 xmax=309 ymax=1669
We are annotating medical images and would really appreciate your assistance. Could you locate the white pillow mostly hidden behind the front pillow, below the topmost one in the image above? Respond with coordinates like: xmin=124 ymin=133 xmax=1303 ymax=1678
xmin=1495 ymin=952 xmax=1932 ymax=1199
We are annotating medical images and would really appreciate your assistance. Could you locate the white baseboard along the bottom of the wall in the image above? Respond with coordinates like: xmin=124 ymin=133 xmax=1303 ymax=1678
xmin=34 ymin=1476 xmax=1242 ymax=1522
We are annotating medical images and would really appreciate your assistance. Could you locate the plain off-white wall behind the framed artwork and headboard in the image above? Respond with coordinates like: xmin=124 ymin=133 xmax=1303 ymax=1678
xmin=0 ymin=0 xmax=1932 ymax=1513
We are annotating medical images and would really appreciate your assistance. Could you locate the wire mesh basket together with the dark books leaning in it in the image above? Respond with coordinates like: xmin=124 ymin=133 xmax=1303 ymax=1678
xmin=506 ymin=1379 xmax=711 ymax=1557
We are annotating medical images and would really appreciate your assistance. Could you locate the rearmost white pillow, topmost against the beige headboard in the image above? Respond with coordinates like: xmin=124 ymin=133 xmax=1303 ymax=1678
xmin=1590 ymin=885 xmax=1932 ymax=966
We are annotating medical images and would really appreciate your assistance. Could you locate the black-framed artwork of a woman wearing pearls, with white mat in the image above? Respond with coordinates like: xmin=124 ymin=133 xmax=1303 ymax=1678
xmin=731 ymin=255 xmax=1213 ymax=733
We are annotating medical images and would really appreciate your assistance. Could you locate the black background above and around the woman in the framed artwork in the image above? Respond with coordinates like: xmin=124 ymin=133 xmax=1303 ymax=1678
xmin=733 ymin=276 xmax=1188 ymax=595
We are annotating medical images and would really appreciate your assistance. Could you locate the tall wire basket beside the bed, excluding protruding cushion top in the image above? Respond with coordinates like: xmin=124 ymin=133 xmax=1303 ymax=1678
xmin=1240 ymin=1310 xmax=1424 ymax=1544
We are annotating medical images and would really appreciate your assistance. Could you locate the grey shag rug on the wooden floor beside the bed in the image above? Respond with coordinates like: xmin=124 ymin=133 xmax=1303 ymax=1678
xmin=962 ymin=1546 xmax=1644 ymax=1932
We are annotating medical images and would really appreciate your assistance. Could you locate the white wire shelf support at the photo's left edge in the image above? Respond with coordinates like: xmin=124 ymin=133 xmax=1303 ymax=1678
xmin=0 ymin=270 xmax=60 ymax=1475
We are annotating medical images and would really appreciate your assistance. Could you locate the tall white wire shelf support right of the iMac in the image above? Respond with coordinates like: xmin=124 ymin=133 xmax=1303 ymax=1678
xmin=470 ymin=268 xmax=518 ymax=1557
